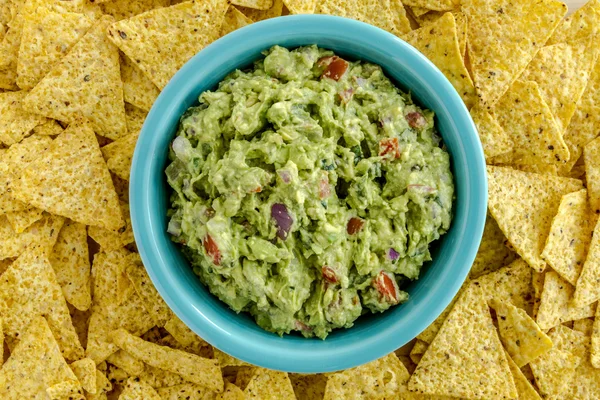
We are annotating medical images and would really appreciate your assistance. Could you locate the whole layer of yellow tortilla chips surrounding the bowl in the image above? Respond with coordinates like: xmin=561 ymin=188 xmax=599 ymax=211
xmin=0 ymin=0 xmax=600 ymax=400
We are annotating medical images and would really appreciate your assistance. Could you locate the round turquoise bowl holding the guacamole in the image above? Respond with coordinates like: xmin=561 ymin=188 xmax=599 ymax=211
xmin=130 ymin=15 xmax=487 ymax=373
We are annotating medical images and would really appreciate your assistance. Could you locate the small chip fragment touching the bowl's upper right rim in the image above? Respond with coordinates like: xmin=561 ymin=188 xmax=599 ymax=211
xmin=470 ymin=106 xmax=513 ymax=161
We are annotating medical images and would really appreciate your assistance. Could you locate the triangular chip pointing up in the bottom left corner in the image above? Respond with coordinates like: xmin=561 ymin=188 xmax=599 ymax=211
xmin=0 ymin=316 xmax=83 ymax=400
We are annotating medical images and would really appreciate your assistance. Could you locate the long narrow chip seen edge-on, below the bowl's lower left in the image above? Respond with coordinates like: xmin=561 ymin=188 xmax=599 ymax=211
xmin=110 ymin=329 xmax=223 ymax=390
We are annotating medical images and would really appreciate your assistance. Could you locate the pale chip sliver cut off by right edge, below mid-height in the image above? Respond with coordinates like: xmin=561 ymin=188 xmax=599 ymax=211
xmin=573 ymin=219 xmax=600 ymax=306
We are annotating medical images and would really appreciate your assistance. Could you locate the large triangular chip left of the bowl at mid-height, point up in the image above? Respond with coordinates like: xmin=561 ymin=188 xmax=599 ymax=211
xmin=13 ymin=120 xmax=123 ymax=230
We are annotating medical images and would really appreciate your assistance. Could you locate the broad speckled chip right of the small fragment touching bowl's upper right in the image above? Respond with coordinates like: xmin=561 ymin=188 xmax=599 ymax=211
xmin=494 ymin=79 xmax=569 ymax=165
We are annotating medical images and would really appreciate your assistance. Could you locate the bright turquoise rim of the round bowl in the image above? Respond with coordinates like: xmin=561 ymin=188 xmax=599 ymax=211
xmin=129 ymin=15 xmax=487 ymax=373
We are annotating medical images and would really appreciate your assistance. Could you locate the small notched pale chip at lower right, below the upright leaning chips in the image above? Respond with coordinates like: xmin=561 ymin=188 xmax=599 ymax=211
xmin=536 ymin=271 xmax=596 ymax=330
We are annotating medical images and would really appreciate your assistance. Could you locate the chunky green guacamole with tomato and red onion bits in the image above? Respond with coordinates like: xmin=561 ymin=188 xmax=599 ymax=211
xmin=166 ymin=46 xmax=454 ymax=338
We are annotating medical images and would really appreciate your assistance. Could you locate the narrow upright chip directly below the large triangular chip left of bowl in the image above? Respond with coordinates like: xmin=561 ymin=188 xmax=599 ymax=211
xmin=50 ymin=220 xmax=92 ymax=311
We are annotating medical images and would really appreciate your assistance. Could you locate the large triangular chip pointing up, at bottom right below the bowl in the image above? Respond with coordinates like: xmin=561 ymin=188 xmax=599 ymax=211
xmin=408 ymin=285 xmax=517 ymax=399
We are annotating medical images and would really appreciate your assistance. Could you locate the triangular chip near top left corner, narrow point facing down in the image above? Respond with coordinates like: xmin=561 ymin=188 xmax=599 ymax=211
xmin=17 ymin=7 xmax=92 ymax=90
